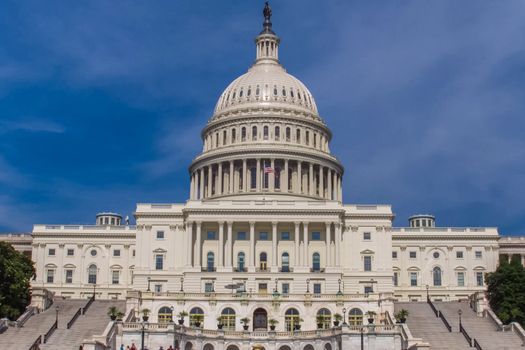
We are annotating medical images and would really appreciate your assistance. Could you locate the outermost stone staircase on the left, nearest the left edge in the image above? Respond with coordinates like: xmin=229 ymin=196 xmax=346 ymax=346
xmin=0 ymin=298 xmax=87 ymax=350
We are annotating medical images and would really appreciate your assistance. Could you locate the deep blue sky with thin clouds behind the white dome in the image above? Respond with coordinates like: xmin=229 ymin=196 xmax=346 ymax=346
xmin=0 ymin=0 xmax=525 ymax=235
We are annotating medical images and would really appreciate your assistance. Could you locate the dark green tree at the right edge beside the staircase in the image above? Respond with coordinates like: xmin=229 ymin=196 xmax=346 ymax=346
xmin=486 ymin=257 xmax=525 ymax=325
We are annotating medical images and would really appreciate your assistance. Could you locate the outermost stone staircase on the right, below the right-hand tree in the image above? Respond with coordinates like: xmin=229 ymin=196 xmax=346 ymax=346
xmin=434 ymin=302 xmax=525 ymax=350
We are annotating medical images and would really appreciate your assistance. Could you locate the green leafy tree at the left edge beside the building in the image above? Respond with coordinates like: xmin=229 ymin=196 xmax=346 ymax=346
xmin=0 ymin=242 xmax=35 ymax=320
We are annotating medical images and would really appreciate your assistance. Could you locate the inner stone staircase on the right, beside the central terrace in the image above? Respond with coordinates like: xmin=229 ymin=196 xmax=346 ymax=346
xmin=394 ymin=302 xmax=470 ymax=350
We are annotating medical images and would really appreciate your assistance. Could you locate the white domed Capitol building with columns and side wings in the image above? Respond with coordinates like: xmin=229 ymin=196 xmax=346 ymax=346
xmin=10 ymin=2 xmax=520 ymax=350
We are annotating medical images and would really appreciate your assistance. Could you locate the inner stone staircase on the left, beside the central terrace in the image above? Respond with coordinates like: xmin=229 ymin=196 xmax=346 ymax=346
xmin=40 ymin=300 xmax=125 ymax=350
